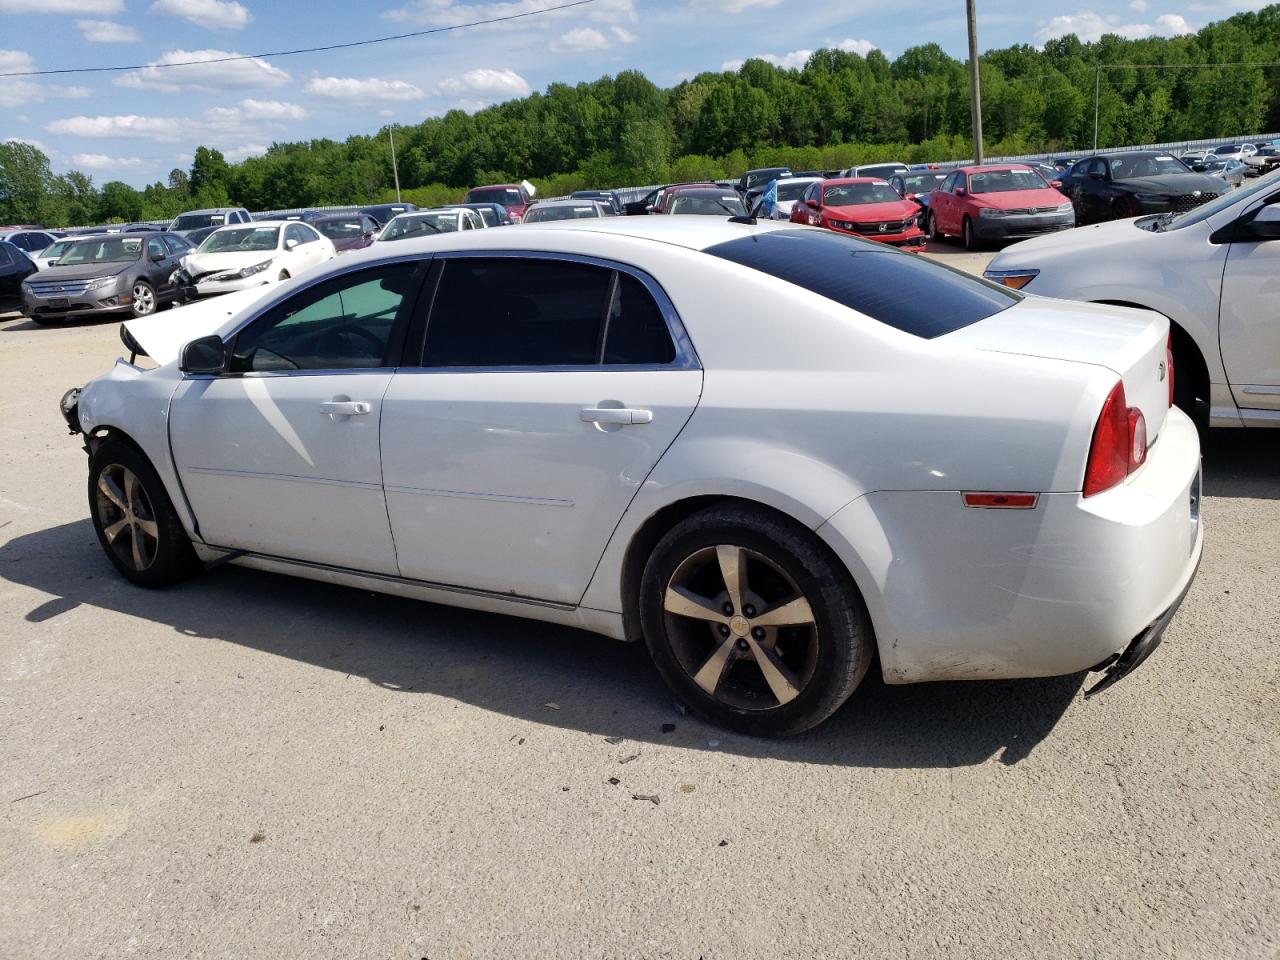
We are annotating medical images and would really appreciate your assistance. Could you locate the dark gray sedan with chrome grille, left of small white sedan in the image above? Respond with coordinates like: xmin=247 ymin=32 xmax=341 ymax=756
xmin=22 ymin=233 xmax=191 ymax=324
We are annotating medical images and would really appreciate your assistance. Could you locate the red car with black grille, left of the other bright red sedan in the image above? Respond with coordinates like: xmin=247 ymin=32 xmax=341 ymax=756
xmin=791 ymin=177 xmax=924 ymax=253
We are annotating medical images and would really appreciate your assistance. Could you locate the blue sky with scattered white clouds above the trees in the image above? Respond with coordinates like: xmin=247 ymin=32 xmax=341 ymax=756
xmin=0 ymin=0 xmax=1263 ymax=186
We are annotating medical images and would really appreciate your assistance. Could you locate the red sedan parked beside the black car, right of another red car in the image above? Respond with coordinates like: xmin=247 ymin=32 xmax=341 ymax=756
xmin=928 ymin=164 xmax=1075 ymax=250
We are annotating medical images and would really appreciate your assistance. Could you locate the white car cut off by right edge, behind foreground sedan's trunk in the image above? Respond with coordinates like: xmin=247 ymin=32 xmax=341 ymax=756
xmin=987 ymin=172 xmax=1280 ymax=426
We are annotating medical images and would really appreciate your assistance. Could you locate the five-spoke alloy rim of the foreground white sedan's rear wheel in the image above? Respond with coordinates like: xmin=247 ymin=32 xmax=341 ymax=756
xmin=662 ymin=544 xmax=818 ymax=710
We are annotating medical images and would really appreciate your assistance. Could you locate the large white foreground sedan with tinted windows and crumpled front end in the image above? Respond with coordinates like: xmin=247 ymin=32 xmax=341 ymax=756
xmin=63 ymin=216 xmax=1203 ymax=735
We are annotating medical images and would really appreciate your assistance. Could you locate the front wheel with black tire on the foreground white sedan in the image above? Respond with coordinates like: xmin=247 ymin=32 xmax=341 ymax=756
xmin=88 ymin=440 xmax=200 ymax=588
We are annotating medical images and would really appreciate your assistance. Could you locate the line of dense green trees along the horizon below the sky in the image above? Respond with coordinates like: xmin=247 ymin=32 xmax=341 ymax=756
xmin=0 ymin=5 xmax=1280 ymax=225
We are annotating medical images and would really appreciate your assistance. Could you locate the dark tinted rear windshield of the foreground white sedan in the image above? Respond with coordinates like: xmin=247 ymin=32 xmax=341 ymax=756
xmin=705 ymin=230 xmax=1021 ymax=340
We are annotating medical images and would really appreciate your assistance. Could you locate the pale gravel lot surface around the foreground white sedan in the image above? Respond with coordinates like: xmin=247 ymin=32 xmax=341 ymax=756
xmin=0 ymin=241 xmax=1280 ymax=960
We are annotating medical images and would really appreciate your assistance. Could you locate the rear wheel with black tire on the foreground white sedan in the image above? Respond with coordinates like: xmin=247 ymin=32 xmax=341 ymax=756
xmin=640 ymin=504 xmax=874 ymax=736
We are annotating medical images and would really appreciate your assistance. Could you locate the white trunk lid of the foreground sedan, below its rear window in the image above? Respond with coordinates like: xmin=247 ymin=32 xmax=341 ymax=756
xmin=945 ymin=297 xmax=1176 ymax=442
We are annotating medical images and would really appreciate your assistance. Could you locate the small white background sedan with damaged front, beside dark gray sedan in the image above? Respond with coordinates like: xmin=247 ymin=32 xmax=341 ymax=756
xmin=182 ymin=220 xmax=338 ymax=300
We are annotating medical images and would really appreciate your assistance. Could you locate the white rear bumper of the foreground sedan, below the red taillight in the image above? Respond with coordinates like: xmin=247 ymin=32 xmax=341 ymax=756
xmin=819 ymin=410 xmax=1203 ymax=684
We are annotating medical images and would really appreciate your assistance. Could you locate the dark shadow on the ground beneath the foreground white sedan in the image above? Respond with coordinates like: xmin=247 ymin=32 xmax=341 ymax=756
xmin=0 ymin=520 xmax=1083 ymax=768
